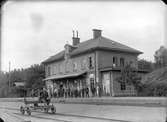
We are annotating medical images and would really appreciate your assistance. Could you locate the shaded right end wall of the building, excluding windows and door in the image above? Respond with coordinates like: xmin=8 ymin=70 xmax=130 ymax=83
xmin=97 ymin=51 xmax=138 ymax=96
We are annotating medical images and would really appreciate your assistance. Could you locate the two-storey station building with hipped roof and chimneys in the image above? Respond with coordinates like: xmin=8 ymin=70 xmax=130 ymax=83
xmin=42 ymin=29 xmax=142 ymax=96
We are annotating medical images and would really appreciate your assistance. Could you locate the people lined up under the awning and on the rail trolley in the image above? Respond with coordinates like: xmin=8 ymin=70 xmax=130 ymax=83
xmin=33 ymin=84 xmax=101 ymax=100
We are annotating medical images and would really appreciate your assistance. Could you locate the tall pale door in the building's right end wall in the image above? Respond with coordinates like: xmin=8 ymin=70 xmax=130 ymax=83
xmin=102 ymin=72 xmax=111 ymax=96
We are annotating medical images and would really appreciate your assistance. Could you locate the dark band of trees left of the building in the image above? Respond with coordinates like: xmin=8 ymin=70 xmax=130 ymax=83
xmin=0 ymin=64 xmax=45 ymax=97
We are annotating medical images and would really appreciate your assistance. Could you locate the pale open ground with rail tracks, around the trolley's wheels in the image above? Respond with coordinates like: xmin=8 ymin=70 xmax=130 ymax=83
xmin=0 ymin=102 xmax=166 ymax=122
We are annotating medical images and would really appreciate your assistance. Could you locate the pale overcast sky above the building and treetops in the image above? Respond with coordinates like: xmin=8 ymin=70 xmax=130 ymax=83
xmin=1 ymin=1 xmax=167 ymax=71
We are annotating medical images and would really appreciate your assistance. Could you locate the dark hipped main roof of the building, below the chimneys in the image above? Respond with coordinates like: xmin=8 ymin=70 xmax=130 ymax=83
xmin=42 ymin=36 xmax=142 ymax=63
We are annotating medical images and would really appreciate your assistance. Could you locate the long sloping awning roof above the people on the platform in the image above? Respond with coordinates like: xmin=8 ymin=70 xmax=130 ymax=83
xmin=44 ymin=72 xmax=86 ymax=81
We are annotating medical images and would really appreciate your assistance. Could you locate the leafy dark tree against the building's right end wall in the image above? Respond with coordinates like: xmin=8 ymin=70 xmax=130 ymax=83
xmin=118 ymin=64 xmax=143 ymax=93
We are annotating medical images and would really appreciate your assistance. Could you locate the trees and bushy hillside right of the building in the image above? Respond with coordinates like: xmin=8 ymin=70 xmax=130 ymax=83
xmin=118 ymin=46 xmax=167 ymax=96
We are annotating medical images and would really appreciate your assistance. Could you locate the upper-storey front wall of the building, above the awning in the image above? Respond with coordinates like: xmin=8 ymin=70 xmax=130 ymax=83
xmin=45 ymin=52 xmax=95 ymax=77
